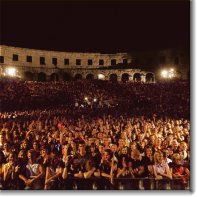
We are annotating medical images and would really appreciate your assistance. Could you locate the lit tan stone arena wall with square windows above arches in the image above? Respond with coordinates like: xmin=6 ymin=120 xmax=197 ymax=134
xmin=0 ymin=45 xmax=155 ymax=82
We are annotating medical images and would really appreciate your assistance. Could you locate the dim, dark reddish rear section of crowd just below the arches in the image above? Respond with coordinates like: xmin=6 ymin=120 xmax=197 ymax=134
xmin=0 ymin=80 xmax=190 ymax=118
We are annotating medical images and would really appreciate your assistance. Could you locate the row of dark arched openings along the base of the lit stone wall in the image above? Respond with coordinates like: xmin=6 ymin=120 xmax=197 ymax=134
xmin=25 ymin=71 xmax=154 ymax=82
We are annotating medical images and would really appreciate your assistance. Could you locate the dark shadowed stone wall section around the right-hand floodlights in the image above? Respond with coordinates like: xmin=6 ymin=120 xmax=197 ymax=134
xmin=132 ymin=48 xmax=190 ymax=81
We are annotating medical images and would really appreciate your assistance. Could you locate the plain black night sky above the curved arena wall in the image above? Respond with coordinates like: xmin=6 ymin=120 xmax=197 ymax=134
xmin=0 ymin=1 xmax=190 ymax=52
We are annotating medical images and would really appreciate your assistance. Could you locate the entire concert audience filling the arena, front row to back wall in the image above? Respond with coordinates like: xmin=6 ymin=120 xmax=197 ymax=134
xmin=0 ymin=80 xmax=190 ymax=190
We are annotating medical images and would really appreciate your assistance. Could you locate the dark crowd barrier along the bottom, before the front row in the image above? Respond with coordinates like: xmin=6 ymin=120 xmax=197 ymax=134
xmin=47 ymin=178 xmax=190 ymax=190
